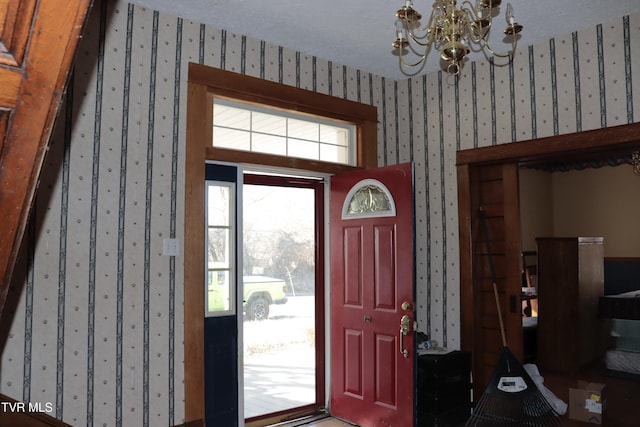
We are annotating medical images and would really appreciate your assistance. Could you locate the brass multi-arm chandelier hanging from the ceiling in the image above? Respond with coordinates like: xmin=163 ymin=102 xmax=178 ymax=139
xmin=392 ymin=0 xmax=522 ymax=76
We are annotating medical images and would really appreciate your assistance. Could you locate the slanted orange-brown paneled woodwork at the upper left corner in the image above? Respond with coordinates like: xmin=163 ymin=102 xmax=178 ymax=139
xmin=0 ymin=0 xmax=92 ymax=320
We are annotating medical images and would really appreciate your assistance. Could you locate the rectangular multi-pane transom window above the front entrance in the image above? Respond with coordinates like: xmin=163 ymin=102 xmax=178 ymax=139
xmin=213 ymin=98 xmax=356 ymax=166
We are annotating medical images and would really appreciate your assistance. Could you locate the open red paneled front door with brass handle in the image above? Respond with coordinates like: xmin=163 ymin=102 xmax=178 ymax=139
xmin=330 ymin=164 xmax=415 ymax=427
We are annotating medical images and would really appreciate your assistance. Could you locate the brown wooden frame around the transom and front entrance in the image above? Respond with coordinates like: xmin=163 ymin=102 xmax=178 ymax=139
xmin=184 ymin=63 xmax=378 ymax=427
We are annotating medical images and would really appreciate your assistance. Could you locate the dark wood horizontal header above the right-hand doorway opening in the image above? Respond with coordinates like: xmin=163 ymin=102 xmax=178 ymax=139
xmin=456 ymin=122 xmax=640 ymax=165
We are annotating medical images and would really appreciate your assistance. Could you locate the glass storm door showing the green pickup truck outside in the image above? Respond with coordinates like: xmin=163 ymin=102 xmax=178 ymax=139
xmin=243 ymin=174 xmax=324 ymax=423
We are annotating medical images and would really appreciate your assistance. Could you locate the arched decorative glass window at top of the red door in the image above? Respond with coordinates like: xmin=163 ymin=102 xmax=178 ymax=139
xmin=342 ymin=179 xmax=396 ymax=219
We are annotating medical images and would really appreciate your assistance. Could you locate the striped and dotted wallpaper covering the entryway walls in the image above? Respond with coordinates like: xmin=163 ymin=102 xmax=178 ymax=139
xmin=0 ymin=0 xmax=640 ymax=426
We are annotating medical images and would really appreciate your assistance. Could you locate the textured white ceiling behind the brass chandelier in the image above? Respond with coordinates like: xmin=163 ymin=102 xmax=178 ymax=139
xmin=130 ymin=0 xmax=640 ymax=79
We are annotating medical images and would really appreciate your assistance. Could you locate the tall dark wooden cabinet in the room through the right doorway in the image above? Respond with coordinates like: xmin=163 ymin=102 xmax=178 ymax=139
xmin=536 ymin=237 xmax=608 ymax=374
